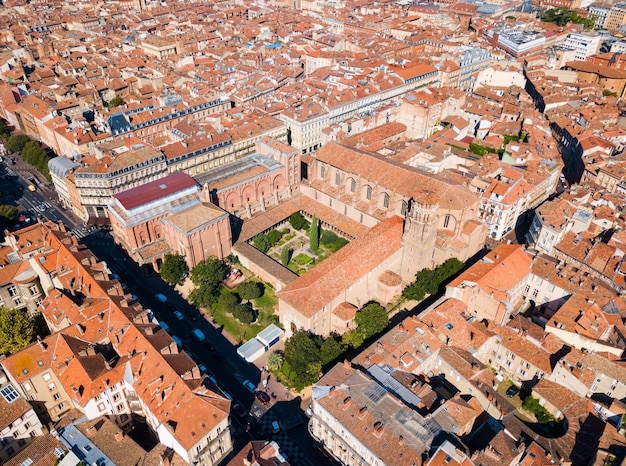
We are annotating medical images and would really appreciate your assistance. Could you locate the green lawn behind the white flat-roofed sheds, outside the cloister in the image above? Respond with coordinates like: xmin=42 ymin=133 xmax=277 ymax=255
xmin=213 ymin=284 xmax=278 ymax=342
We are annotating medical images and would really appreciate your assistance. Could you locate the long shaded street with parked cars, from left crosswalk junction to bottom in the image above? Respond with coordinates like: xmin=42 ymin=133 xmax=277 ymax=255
xmin=0 ymin=156 xmax=334 ymax=465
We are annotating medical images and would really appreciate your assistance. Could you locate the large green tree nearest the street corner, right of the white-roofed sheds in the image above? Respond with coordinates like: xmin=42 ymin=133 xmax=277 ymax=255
xmin=285 ymin=330 xmax=322 ymax=390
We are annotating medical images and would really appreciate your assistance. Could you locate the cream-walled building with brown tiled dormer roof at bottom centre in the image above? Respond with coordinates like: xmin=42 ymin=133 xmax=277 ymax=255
xmin=309 ymin=363 xmax=441 ymax=466
